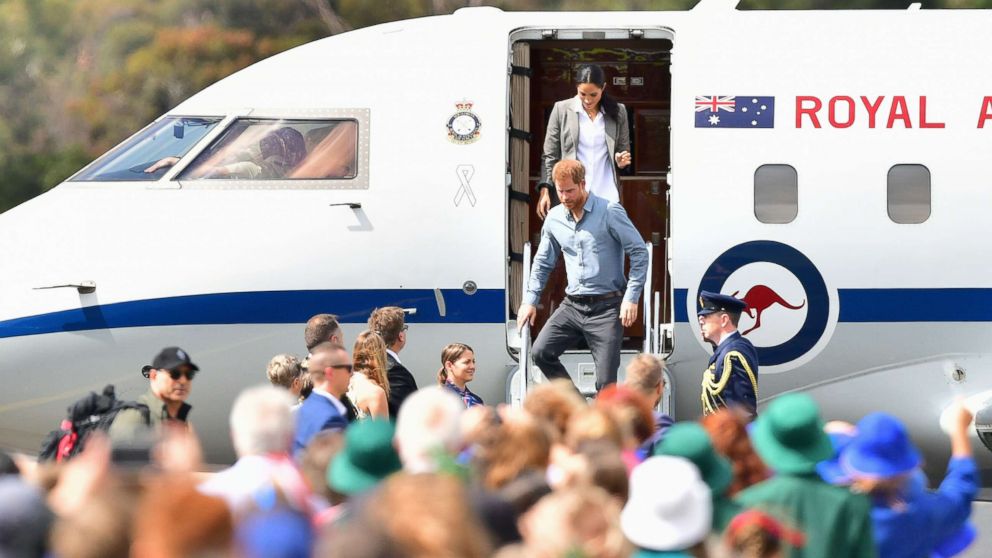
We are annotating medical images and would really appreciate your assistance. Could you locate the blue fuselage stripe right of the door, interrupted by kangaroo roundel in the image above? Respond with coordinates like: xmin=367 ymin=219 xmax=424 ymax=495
xmin=675 ymin=289 xmax=992 ymax=323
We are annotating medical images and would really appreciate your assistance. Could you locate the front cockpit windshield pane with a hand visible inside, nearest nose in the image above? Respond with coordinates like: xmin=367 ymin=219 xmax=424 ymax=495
xmin=72 ymin=116 xmax=222 ymax=182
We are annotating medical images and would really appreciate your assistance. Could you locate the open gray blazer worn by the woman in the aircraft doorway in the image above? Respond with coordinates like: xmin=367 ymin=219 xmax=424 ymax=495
xmin=537 ymin=97 xmax=630 ymax=191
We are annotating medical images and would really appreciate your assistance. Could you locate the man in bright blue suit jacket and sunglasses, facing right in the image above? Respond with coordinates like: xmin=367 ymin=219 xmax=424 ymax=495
xmin=293 ymin=341 xmax=352 ymax=456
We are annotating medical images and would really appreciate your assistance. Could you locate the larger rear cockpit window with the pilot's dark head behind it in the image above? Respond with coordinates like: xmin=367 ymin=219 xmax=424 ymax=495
xmin=179 ymin=118 xmax=358 ymax=180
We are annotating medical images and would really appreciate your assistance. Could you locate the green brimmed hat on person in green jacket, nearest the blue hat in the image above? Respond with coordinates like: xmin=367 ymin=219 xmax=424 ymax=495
xmin=752 ymin=393 xmax=833 ymax=473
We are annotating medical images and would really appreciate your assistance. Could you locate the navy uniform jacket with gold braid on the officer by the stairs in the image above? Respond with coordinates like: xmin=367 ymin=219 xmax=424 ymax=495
xmin=702 ymin=331 xmax=758 ymax=419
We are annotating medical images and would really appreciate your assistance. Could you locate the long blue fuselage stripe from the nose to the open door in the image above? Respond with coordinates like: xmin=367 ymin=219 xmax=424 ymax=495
xmin=0 ymin=289 xmax=506 ymax=338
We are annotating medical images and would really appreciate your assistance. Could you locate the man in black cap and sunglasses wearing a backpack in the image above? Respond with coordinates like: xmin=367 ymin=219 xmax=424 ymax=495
xmin=110 ymin=347 xmax=200 ymax=439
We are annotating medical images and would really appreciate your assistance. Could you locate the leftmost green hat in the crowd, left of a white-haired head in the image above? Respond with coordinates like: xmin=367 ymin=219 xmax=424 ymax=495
xmin=327 ymin=420 xmax=403 ymax=495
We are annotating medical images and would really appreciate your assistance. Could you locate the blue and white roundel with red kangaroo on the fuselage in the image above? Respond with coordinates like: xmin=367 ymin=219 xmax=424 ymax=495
xmin=687 ymin=240 xmax=837 ymax=372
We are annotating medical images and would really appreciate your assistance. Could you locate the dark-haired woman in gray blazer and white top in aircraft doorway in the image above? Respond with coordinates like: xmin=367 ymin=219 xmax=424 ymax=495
xmin=537 ymin=64 xmax=630 ymax=219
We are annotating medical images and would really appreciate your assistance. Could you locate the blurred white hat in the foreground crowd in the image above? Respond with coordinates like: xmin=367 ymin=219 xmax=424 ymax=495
xmin=620 ymin=455 xmax=713 ymax=550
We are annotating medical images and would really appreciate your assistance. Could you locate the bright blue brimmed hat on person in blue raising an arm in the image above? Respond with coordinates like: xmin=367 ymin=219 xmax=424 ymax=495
xmin=840 ymin=413 xmax=921 ymax=479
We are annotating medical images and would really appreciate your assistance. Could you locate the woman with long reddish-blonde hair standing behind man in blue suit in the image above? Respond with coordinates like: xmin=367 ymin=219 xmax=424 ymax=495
xmin=348 ymin=330 xmax=389 ymax=420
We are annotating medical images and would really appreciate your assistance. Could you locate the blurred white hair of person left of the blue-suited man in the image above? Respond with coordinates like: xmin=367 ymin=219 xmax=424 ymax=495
xmin=231 ymin=386 xmax=296 ymax=457
